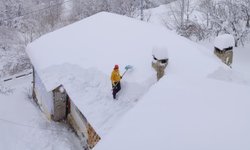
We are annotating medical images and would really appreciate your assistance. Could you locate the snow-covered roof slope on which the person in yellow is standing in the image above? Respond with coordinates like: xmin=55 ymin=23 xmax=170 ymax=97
xmin=26 ymin=12 xmax=224 ymax=137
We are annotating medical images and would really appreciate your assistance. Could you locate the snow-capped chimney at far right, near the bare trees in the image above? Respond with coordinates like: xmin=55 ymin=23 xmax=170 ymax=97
xmin=214 ymin=34 xmax=235 ymax=67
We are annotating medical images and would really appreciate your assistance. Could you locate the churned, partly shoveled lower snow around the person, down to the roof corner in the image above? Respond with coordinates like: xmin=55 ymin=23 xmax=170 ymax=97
xmin=43 ymin=63 xmax=156 ymax=137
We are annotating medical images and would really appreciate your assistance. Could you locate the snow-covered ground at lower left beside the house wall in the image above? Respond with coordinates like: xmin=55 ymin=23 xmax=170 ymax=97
xmin=0 ymin=75 xmax=82 ymax=150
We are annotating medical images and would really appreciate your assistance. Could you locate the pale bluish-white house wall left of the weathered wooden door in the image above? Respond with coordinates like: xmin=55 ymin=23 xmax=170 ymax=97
xmin=34 ymin=70 xmax=54 ymax=119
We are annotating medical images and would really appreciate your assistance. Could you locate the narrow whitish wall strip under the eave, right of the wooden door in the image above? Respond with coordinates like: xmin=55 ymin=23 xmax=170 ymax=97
xmin=70 ymin=101 xmax=88 ymax=139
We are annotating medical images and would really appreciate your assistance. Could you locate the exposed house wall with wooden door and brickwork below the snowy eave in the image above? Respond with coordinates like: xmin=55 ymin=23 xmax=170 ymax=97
xmin=33 ymin=67 xmax=101 ymax=149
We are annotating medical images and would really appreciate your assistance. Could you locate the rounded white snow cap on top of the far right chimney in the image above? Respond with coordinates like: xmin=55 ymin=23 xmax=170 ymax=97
xmin=214 ymin=34 xmax=234 ymax=50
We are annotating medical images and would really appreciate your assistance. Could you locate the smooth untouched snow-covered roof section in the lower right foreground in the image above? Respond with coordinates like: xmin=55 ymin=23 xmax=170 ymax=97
xmin=94 ymin=75 xmax=250 ymax=150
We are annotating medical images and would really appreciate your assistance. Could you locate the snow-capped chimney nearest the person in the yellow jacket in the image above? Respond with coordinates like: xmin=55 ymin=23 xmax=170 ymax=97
xmin=152 ymin=47 xmax=168 ymax=80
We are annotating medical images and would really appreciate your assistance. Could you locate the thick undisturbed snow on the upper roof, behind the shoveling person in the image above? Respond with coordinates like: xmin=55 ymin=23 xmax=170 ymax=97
xmin=27 ymin=12 xmax=223 ymax=91
